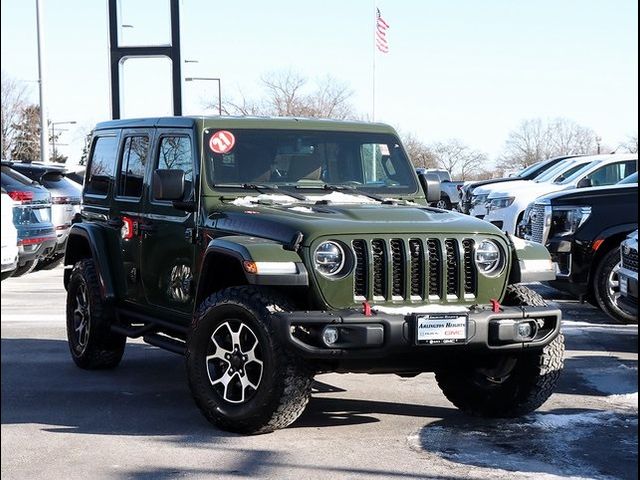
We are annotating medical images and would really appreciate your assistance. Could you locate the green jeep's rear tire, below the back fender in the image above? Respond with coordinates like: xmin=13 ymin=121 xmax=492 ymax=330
xmin=67 ymin=259 xmax=127 ymax=370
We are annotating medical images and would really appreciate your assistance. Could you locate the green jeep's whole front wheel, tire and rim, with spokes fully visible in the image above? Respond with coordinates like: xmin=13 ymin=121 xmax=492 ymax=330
xmin=186 ymin=287 xmax=313 ymax=434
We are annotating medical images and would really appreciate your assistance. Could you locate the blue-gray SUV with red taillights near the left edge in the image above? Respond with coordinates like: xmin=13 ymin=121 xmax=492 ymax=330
xmin=2 ymin=162 xmax=56 ymax=277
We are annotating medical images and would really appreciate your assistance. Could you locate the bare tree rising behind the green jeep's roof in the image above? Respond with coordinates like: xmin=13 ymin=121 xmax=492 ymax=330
xmin=223 ymin=70 xmax=356 ymax=119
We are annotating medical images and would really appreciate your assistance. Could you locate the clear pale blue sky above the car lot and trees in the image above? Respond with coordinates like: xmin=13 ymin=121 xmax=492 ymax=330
xmin=1 ymin=0 xmax=638 ymax=162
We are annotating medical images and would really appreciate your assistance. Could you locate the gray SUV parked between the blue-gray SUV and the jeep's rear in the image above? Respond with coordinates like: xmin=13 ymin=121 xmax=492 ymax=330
xmin=11 ymin=162 xmax=82 ymax=269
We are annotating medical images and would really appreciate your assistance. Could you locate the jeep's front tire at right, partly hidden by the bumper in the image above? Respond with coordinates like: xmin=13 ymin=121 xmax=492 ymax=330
xmin=436 ymin=285 xmax=564 ymax=418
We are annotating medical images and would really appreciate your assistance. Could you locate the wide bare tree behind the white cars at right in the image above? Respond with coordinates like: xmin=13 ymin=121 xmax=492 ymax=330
xmin=498 ymin=118 xmax=598 ymax=170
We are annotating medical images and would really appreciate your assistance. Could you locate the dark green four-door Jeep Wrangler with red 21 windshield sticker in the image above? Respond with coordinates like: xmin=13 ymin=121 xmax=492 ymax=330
xmin=64 ymin=117 xmax=564 ymax=433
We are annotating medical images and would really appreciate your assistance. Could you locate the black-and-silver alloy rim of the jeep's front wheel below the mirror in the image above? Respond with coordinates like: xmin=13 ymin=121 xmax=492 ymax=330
xmin=205 ymin=320 xmax=264 ymax=404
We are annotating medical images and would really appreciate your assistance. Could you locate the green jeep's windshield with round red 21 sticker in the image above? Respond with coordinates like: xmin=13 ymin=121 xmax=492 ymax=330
xmin=204 ymin=129 xmax=418 ymax=194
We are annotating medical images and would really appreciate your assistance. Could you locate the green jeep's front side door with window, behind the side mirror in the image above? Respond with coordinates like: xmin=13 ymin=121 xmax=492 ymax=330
xmin=139 ymin=128 xmax=197 ymax=318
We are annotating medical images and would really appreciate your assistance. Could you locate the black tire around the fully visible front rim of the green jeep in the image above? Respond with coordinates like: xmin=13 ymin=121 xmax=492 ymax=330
xmin=186 ymin=286 xmax=314 ymax=434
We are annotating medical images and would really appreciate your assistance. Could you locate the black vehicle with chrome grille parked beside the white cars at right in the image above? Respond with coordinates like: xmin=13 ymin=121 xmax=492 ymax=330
xmin=518 ymin=172 xmax=638 ymax=323
